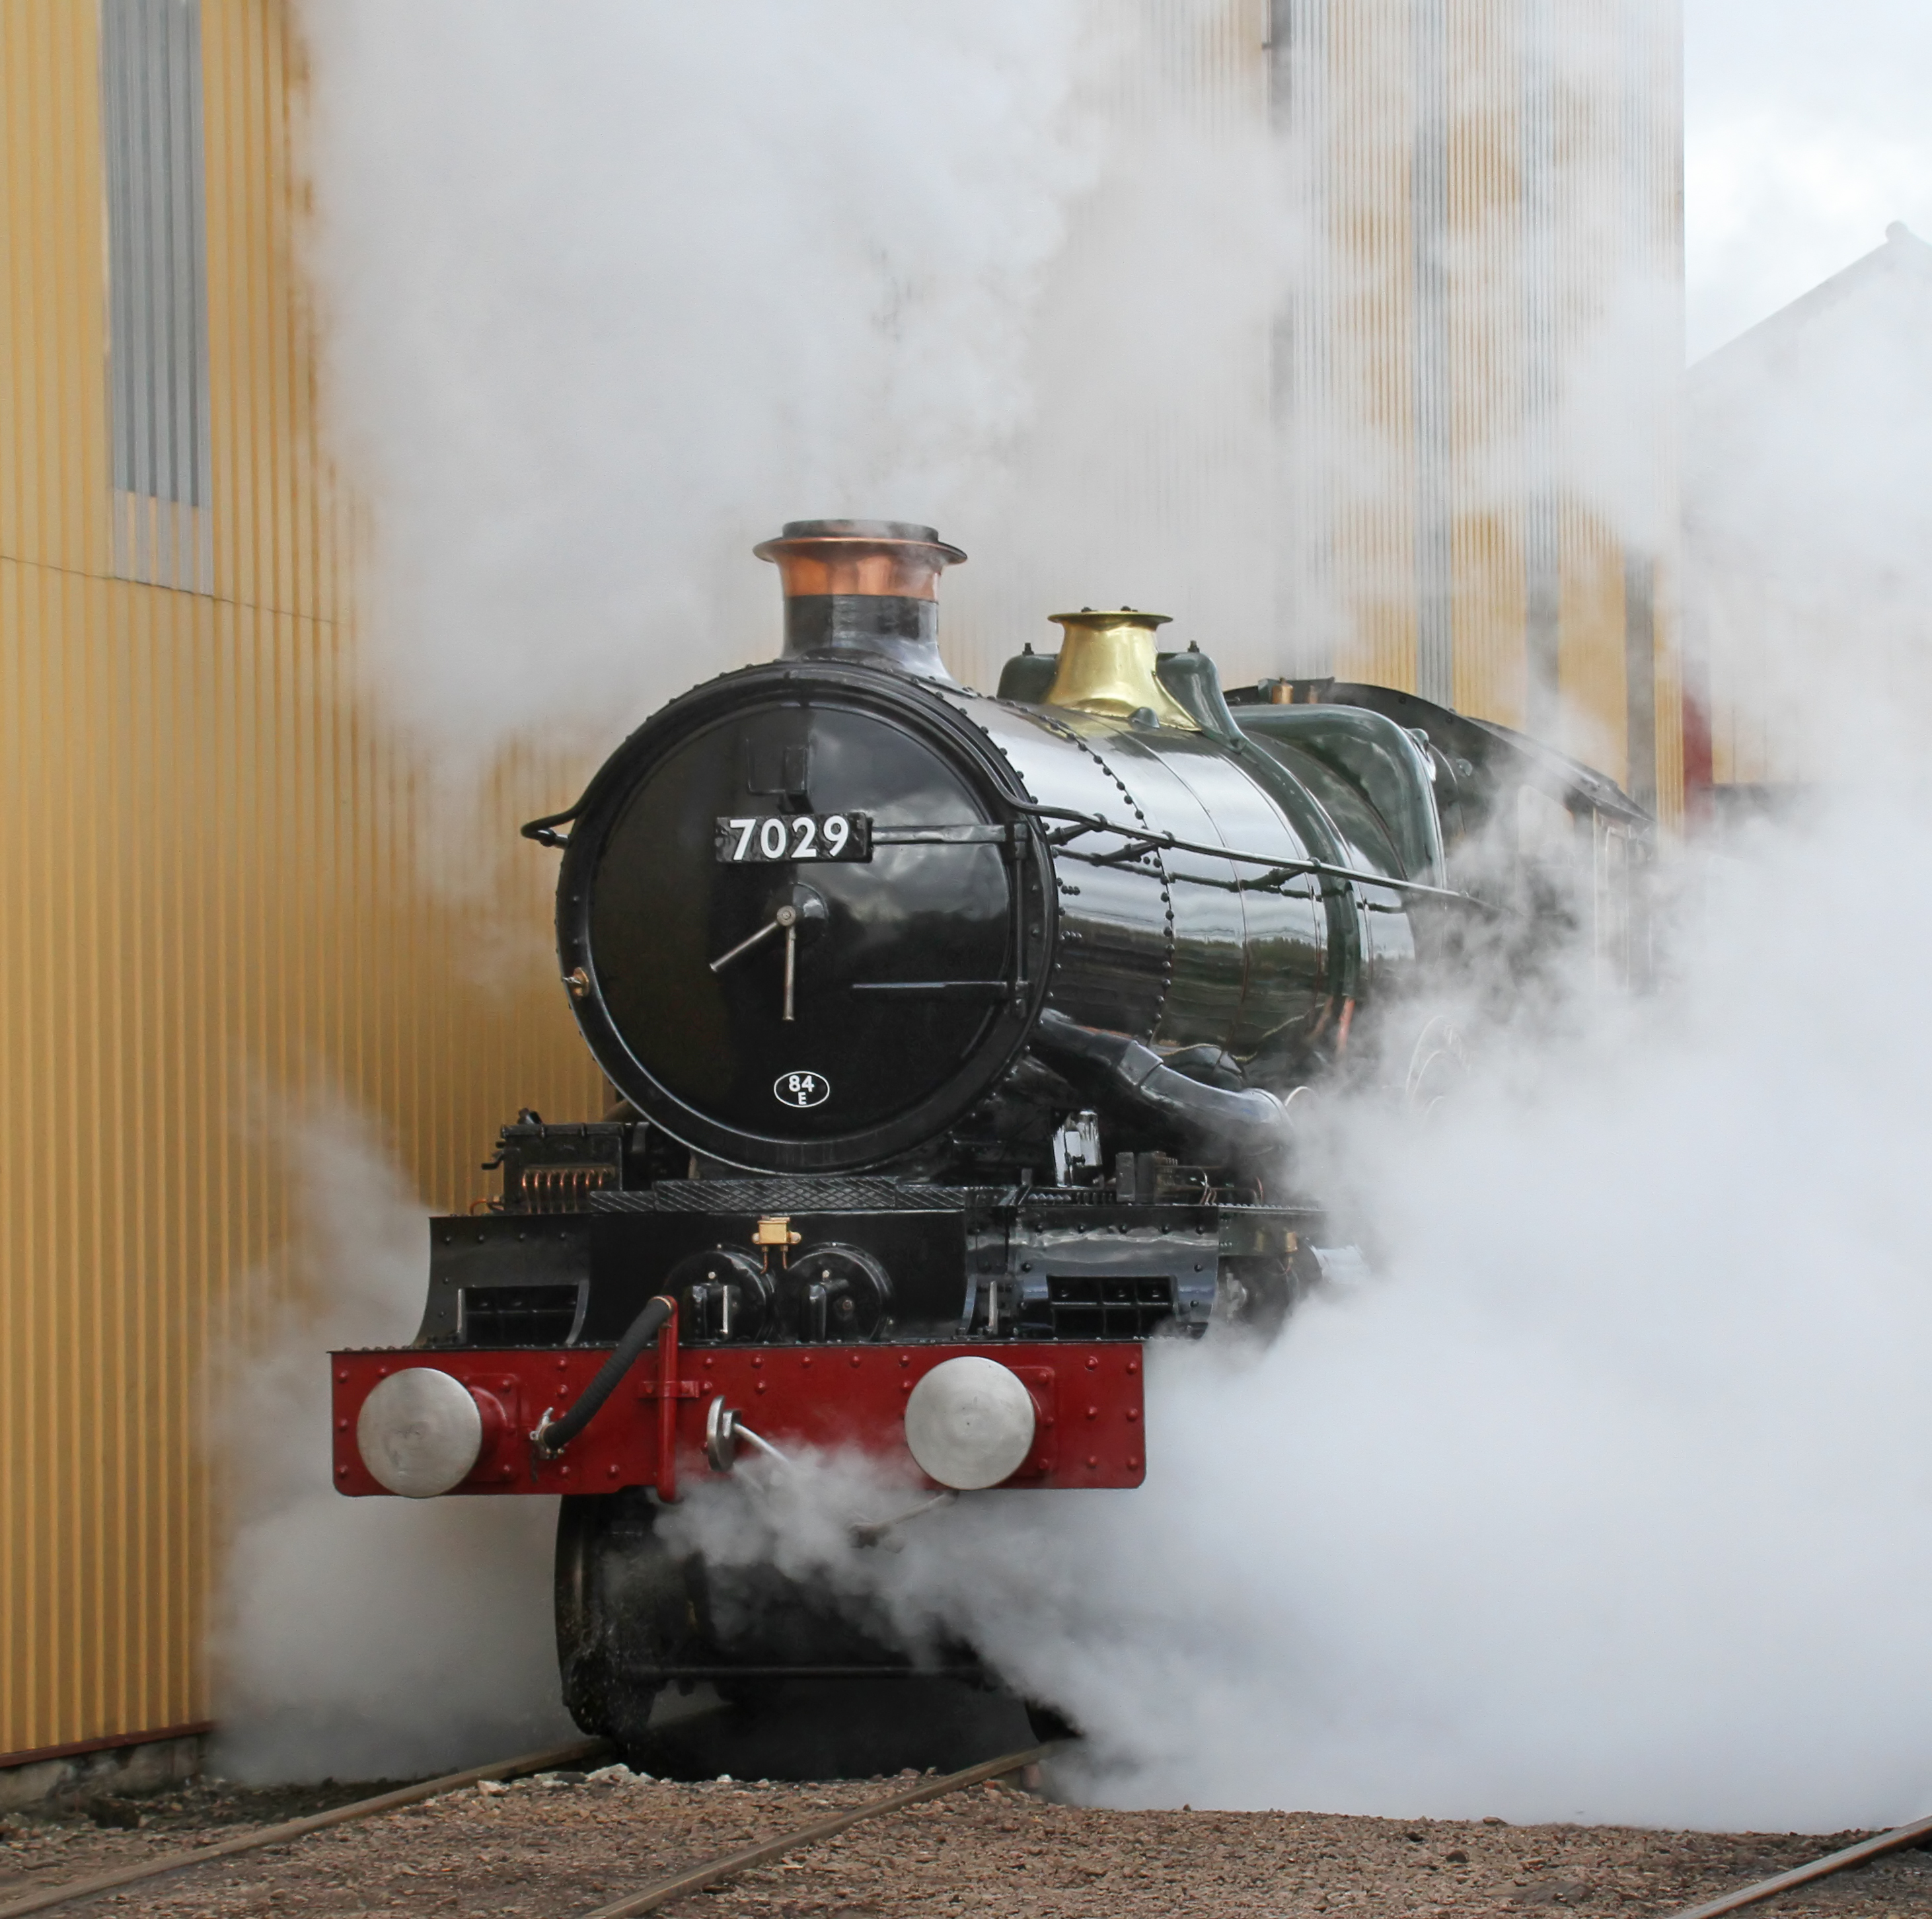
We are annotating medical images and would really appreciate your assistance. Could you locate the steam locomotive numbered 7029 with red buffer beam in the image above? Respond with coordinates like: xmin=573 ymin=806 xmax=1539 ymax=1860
xmin=330 ymin=520 xmax=1650 ymax=1747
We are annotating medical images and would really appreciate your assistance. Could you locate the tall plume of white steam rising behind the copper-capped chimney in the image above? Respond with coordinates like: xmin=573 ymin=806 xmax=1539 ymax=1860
xmin=303 ymin=0 xmax=1314 ymax=734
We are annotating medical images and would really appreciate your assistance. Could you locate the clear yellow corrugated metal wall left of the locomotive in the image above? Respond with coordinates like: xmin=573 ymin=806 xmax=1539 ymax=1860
xmin=0 ymin=0 xmax=599 ymax=1758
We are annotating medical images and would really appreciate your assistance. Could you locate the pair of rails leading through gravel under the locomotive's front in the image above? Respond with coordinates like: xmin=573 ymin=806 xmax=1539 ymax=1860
xmin=0 ymin=1739 xmax=1047 ymax=1919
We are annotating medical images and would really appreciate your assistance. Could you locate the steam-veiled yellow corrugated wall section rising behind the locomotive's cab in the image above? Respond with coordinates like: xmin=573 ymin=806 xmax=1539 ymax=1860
xmin=1269 ymin=0 xmax=1683 ymax=823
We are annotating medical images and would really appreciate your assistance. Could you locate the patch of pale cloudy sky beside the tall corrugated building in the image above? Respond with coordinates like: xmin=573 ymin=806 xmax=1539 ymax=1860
xmin=1685 ymin=0 xmax=1932 ymax=361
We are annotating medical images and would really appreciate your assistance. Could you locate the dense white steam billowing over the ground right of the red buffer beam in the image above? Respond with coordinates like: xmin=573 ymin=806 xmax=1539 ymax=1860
xmin=692 ymin=796 xmax=1932 ymax=1830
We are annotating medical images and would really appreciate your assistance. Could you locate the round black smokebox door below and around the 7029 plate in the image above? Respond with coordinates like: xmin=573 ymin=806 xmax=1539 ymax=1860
xmin=589 ymin=704 xmax=1012 ymax=1140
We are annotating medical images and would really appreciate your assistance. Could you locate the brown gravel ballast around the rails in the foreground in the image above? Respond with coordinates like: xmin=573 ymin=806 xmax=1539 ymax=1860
xmin=0 ymin=1770 xmax=1932 ymax=1919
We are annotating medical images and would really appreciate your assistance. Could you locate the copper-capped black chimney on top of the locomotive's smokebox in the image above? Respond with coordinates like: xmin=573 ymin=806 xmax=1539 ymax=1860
xmin=751 ymin=520 xmax=966 ymax=684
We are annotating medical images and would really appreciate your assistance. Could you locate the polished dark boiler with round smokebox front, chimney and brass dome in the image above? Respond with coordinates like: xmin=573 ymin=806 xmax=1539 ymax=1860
xmin=537 ymin=522 xmax=1445 ymax=1177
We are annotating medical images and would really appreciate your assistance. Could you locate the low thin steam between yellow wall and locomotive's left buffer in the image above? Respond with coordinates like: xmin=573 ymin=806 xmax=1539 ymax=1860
xmin=213 ymin=1113 xmax=574 ymax=1780
